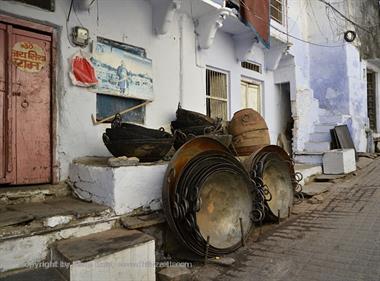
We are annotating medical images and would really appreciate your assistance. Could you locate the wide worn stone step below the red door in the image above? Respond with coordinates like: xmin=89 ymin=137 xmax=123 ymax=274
xmin=0 ymin=197 xmax=119 ymax=274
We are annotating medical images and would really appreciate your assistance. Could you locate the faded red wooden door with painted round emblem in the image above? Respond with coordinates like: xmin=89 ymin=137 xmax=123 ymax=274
xmin=0 ymin=25 xmax=52 ymax=184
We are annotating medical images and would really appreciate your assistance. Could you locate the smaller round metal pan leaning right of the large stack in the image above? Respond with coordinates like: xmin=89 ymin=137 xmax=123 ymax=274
xmin=244 ymin=145 xmax=296 ymax=220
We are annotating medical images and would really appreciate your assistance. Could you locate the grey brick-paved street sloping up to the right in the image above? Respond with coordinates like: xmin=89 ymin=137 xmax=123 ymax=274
xmin=197 ymin=158 xmax=380 ymax=281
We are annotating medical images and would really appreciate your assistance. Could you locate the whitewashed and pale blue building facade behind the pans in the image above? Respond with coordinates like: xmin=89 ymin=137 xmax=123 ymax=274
xmin=0 ymin=0 xmax=380 ymax=183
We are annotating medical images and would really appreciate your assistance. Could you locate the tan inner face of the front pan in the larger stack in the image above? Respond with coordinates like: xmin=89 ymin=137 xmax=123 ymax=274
xmin=196 ymin=168 xmax=252 ymax=249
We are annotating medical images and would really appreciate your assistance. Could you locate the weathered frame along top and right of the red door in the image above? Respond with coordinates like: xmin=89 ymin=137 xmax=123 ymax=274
xmin=0 ymin=12 xmax=59 ymax=184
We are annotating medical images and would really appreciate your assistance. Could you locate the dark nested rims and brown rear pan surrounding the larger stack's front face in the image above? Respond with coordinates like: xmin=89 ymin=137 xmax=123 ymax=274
xmin=162 ymin=136 xmax=252 ymax=256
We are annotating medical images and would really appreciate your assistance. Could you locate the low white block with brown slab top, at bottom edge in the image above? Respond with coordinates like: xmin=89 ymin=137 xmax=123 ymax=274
xmin=51 ymin=229 xmax=155 ymax=281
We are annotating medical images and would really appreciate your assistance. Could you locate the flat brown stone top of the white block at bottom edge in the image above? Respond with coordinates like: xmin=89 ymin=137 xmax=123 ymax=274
xmin=54 ymin=229 xmax=154 ymax=262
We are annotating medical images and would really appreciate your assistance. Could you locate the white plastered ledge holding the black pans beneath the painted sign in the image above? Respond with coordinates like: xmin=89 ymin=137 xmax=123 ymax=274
xmin=69 ymin=157 xmax=168 ymax=215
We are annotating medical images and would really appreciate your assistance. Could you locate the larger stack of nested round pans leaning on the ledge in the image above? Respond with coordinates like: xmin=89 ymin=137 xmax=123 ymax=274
xmin=162 ymin=137 xmax=254 ymax=256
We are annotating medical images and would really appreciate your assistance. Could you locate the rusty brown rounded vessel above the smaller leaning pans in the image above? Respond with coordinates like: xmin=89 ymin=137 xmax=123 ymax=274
xmin=228 ymin=108 xmax=270 ymax=156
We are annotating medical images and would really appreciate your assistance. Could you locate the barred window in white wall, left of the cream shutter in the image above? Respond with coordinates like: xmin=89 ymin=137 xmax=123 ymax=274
xmin=206 ymin=69 xmax=228 ymax=120
